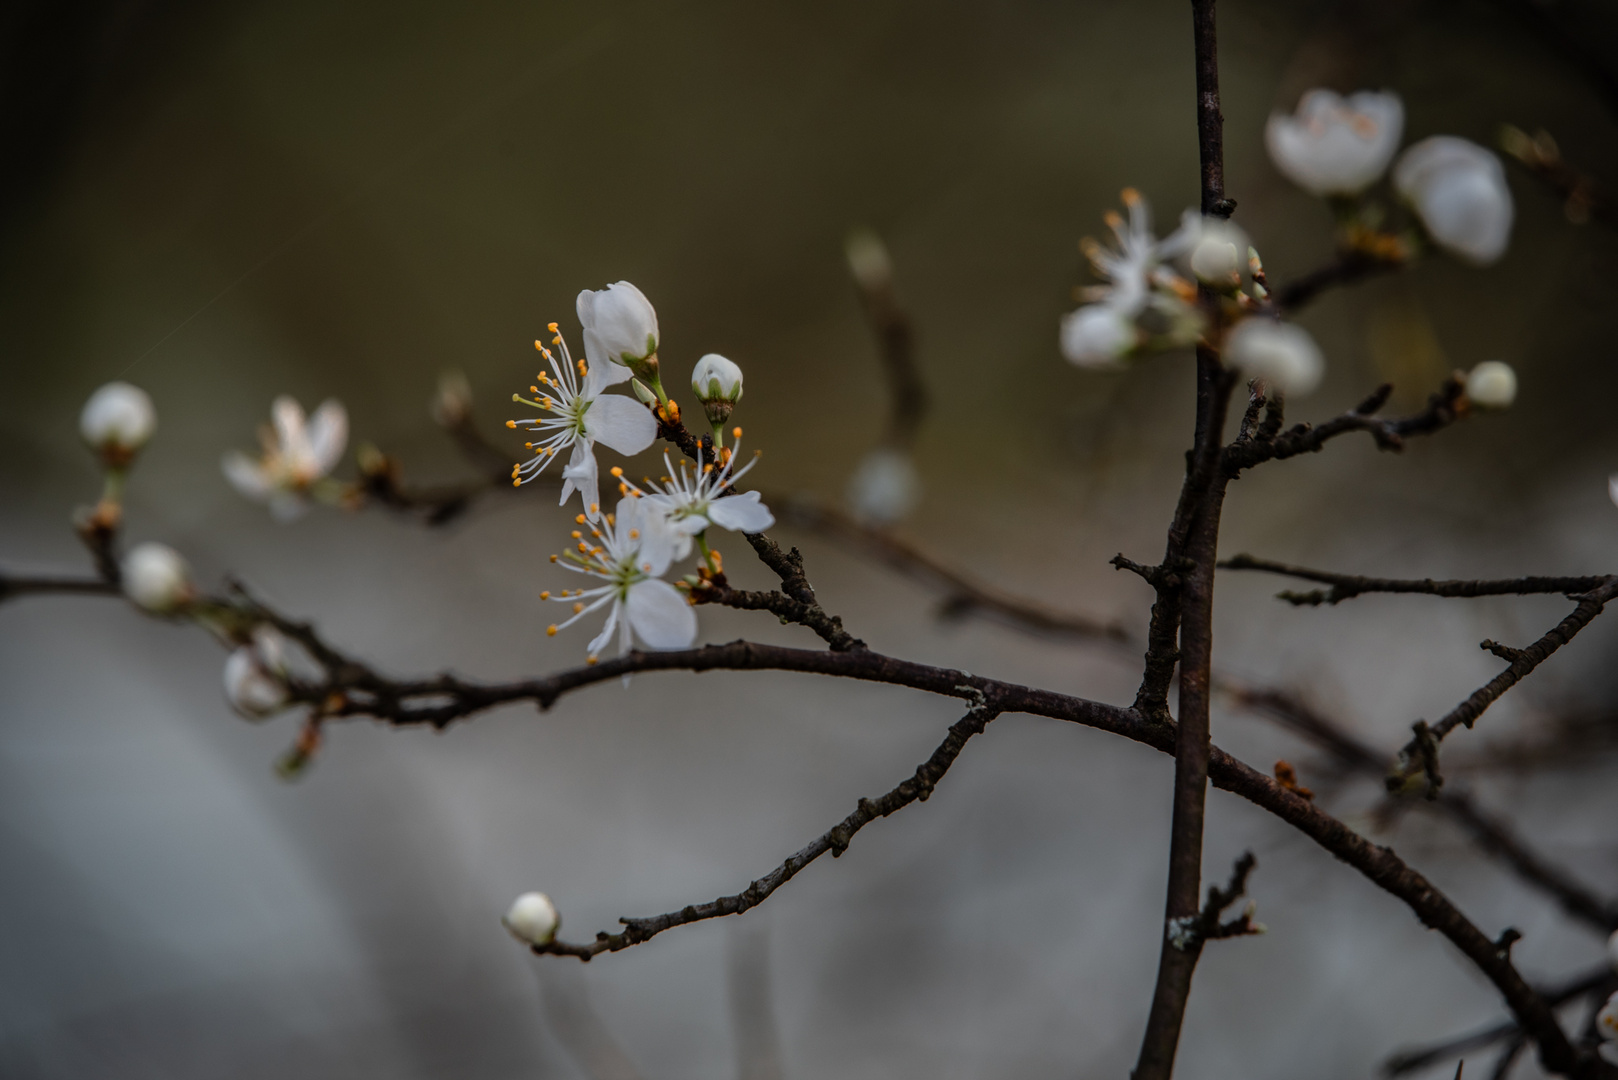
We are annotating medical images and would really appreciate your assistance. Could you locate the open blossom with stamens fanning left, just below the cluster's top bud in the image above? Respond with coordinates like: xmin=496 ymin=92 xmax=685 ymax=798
xmin=506 ymin=322 xmax=657 ymax=521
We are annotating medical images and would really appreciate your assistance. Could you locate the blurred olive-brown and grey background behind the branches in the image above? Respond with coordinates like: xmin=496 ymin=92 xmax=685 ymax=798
xmin=0 ymin=0 xmax=1618 ymax=1080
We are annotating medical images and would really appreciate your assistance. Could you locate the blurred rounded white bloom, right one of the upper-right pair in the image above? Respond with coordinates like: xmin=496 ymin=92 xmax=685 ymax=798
xmin=1393 ymin=134 xmax=1513 ymax=266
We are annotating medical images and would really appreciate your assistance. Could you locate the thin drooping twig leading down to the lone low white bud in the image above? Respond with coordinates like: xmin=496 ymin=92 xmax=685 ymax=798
xmin=531 ymin=706 xmax=995 ymax=960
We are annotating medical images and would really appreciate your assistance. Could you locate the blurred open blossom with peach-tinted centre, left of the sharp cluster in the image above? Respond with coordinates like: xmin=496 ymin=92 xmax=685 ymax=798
xmin=223 ymin=395 xmax=348 ymax=521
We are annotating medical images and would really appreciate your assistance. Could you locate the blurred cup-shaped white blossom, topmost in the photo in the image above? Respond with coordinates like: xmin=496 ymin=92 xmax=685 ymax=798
xmin=1264 ymin=89 xmax=1404 ymax=196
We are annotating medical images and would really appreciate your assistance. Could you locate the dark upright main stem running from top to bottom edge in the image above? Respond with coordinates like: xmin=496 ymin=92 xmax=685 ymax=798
xmin=1134 ymin=0 xmax=1236 ymax=1080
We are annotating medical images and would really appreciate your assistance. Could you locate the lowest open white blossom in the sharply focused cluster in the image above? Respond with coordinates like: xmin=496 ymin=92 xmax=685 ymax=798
xmin=544 ymin=494 xmax=697 ymax=662
